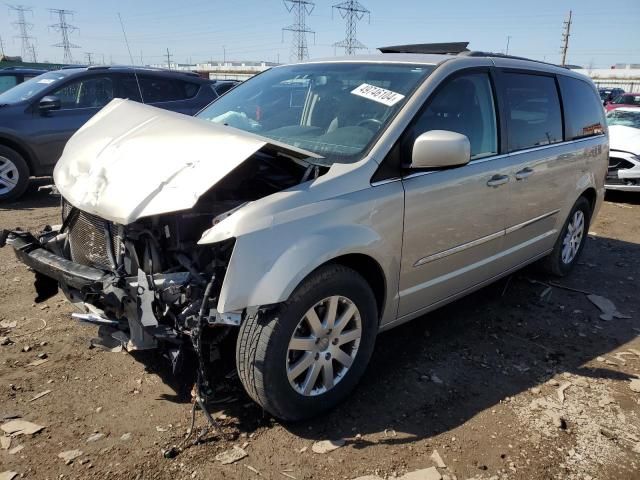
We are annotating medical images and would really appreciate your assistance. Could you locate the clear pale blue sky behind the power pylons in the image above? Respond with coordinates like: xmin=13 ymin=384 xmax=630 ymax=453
xmin=0 ymin=0 xmax=640 ymax=68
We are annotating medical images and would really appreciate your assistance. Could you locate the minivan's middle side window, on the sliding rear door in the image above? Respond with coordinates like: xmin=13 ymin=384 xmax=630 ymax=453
xmin=504 ymin=73 xmax=562 ymax=151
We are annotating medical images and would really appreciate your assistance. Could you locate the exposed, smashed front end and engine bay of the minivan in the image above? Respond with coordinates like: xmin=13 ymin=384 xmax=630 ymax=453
xmin=0 ymin=145 xmax=326 ymax=402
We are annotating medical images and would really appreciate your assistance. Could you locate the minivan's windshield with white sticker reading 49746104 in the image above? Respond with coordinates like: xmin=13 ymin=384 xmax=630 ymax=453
xmin=198 ymin=62 xmax=434 ymax=164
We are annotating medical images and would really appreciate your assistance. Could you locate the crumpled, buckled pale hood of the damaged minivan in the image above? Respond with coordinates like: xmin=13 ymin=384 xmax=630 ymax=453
xmin=53 ymin=99 xmax=317 ymax=225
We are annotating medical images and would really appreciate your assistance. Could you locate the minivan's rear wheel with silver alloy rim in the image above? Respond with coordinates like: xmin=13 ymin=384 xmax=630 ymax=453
xmin=542 ymin=197 xmax=592 ymax=277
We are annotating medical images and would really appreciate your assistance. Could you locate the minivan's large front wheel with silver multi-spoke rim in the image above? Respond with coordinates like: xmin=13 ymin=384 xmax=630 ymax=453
xmin=236 ymin=264 xmax=378 ymax=421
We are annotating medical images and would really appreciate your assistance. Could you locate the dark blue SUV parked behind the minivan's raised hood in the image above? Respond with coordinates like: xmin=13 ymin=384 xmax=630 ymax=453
xmin=0 ymin=66 xmax=221 ymax=201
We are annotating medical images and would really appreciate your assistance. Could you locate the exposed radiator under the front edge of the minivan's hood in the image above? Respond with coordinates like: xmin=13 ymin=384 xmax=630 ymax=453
xmin=62 ymin=201 xmax=120 ymax=270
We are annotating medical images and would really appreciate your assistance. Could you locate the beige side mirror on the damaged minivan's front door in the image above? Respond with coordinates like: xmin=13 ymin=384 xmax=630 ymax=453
xmin=411 ymin=130 xmax=471 ymax=168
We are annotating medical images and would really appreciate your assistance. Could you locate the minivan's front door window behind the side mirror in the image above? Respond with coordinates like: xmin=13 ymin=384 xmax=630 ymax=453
xmin=408 ymin=73 xmax=498 ymax=160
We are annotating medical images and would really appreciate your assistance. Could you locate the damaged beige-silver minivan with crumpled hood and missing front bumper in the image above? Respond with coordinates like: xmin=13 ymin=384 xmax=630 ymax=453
xmin=0 ymin=48 xmax=608 ymax=420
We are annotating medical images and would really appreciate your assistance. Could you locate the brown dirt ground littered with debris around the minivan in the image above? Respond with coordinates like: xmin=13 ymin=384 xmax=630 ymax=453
xmin=0 ymin=185 xmax=640 ymax=480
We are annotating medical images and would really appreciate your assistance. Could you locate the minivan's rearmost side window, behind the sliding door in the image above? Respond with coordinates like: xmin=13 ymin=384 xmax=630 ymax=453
xmin=558 ymin=75 xmax=604 ymax=140
